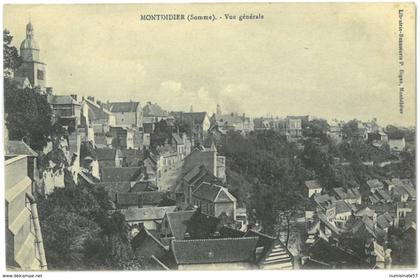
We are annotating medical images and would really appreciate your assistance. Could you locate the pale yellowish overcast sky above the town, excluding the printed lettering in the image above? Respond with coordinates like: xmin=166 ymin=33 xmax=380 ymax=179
xmin=4 ymin=4 xmax=415 ymax=125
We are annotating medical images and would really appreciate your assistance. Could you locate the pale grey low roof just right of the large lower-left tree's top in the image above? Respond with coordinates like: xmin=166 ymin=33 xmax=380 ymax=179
xmin=120 ymin=206 xmax=176 ymax=222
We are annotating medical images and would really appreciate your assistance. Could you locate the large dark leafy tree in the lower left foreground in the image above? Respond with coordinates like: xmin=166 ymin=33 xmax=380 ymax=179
xmin=38 ymin=185 xmax=142 ymax=270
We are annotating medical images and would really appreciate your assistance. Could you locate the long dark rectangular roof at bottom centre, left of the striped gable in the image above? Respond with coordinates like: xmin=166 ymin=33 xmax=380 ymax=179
xmin=171 ymin=237 xmax=258 ymax=264
